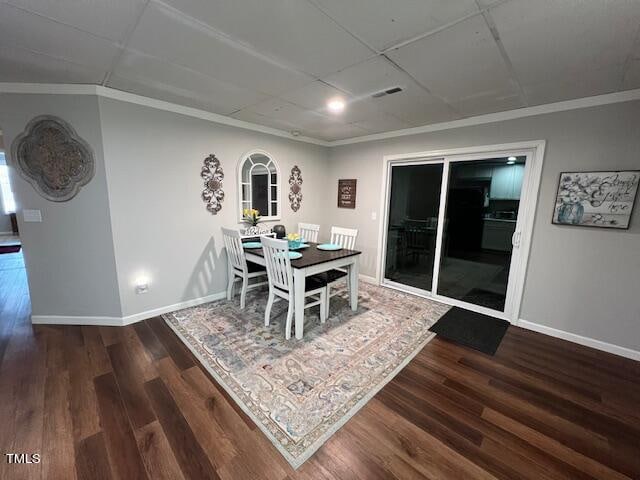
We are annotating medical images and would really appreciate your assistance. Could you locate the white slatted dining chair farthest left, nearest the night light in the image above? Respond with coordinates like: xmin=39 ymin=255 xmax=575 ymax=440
xmin=222 ymin=227 xmax=267 ymax=309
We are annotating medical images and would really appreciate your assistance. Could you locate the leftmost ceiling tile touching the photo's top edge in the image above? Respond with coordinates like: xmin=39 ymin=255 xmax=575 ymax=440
xmin=7 ymin=0 xmax=146 ymax=42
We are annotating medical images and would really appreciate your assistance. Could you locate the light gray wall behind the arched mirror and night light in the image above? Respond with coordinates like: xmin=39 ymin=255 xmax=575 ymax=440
xmin=99 ymin=98 xmax=328 ymax=315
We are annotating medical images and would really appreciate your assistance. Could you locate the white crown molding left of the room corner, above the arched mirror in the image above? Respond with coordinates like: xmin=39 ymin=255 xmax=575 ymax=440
xmin=0 ymin=82 xmax=329 ymax=147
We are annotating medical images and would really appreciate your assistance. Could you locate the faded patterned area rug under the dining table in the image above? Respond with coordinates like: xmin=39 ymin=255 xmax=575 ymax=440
xmin=163 ymin=284 xmax=449 ymax=468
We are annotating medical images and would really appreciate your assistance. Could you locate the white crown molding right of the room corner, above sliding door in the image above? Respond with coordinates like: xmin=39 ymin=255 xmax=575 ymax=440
xmin=328 ymin=88 xmax=640 ymax=147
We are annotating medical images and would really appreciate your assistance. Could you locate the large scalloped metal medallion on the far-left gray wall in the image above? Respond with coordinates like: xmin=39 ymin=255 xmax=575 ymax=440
xmin=11 ymin=115 xmax=95 ymax=202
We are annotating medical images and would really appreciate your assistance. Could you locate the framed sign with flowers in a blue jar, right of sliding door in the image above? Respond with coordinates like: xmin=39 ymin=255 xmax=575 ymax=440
xmin=553 ymin=170 xmax=640 ymax=229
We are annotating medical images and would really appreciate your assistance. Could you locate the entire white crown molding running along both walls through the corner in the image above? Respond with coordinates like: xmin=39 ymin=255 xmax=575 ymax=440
xmin=5 ymin=82 xmax=640 ymax=147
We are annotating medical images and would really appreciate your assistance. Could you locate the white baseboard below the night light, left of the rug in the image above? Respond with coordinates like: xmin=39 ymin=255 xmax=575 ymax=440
xmin=31 ymin=292 xmax=227 ymax=327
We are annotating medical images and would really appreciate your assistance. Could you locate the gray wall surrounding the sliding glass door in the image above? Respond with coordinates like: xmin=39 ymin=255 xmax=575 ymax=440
xmin=327 ymin=102 xmax=640 ymax=350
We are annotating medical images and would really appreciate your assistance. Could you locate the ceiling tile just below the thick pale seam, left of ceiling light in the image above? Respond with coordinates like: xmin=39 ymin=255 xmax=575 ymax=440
xmin=129 ymin=3 xmax=313 ymax=95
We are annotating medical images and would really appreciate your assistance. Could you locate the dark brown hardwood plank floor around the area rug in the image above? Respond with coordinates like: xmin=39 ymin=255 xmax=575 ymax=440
xmin=0 ymin=255 xmax=640 ymax=480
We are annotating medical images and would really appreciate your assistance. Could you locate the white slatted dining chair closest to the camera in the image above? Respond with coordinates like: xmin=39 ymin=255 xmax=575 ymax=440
xmin=262 ymin=238 xmax=327 ymax=340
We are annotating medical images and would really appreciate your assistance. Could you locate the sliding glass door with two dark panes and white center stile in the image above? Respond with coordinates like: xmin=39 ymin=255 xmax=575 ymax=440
xmin=384 ymin=153 xmax=527 ymax=316
